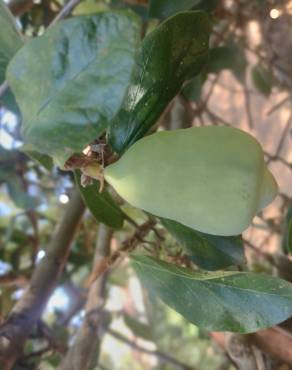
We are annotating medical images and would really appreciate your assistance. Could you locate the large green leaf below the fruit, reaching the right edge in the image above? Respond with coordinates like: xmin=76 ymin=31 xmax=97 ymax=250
xmin=132 ymin=256 xmax=292 ymax=333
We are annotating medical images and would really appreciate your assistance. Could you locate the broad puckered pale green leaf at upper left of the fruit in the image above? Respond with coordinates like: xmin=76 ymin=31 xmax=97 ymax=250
xmin=7 ymin=11 xmax=140 ymax=167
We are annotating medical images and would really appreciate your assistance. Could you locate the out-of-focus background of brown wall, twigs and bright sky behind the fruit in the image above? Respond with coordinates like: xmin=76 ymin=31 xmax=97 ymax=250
xmin=0 ymin=0 xmax=292 ymax=370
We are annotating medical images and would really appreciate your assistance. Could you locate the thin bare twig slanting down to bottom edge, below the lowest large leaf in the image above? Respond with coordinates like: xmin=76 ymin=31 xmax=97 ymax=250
xmin=107 ymin=329 xmax=196 ymax=370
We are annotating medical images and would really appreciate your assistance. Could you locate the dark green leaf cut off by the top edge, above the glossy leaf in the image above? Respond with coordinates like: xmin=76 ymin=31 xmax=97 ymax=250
xmin=149 ymin=0 xmax=200 ymax=18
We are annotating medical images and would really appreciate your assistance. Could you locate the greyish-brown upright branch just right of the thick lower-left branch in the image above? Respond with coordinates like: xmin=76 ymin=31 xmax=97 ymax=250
xmin=59 ymin=224 xmax=112 ymax=370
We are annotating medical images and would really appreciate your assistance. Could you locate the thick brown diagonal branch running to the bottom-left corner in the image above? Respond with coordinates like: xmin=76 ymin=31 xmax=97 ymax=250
xmin=0 ymin=192 xmax=85 ymax=370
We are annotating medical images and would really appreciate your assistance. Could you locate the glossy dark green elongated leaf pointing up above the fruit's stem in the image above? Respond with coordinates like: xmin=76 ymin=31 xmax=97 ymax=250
xmin=109 ymin=11 xmax=210 ymax=153
